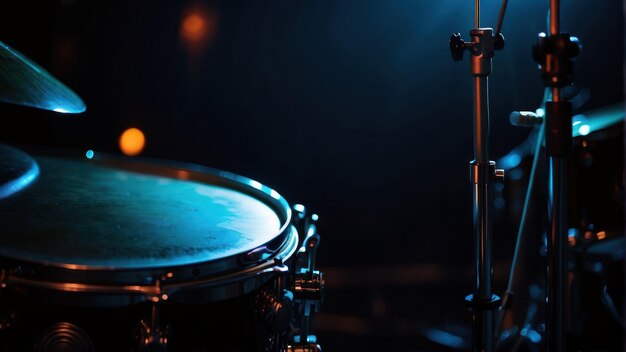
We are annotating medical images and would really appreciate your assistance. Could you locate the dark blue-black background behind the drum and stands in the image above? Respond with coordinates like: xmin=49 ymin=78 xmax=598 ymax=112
xmin=0 ymin=0 xmax=624 ymax=350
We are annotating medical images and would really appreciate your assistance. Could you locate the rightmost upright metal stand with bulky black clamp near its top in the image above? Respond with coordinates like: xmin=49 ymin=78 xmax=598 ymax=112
xmin=533 ymin=0 xmax=580 ymax=352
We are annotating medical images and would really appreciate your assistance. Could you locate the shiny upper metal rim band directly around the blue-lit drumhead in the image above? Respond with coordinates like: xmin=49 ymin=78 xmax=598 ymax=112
xmin=0 ymin=145 xmax=297 ymax=286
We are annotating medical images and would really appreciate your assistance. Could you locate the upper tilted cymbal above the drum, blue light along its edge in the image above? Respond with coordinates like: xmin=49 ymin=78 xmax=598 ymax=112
xmin=0 ymin=41 xmax=86 ymax=114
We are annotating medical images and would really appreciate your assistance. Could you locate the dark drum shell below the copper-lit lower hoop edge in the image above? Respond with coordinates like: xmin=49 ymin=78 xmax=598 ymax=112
xmin=0 ymin=282 xmax=276 ymax=352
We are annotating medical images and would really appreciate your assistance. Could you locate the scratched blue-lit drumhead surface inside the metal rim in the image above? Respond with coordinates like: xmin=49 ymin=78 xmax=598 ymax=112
xmin=0 ymin=153 xmax=282 ymax=268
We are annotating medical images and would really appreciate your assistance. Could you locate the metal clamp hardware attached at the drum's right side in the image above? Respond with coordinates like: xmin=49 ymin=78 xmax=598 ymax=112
xmin=287 ymin=204 xmax=324 ymax=352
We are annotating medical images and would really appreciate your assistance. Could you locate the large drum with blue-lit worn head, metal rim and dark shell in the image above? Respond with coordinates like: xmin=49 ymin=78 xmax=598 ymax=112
xmin=0 ymin=145 xmax=299 ymax=352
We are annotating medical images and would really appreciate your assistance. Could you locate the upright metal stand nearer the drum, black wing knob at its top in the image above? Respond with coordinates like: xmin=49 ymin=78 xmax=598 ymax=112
xmin=450 ymin=0 xmax=504 ymax=352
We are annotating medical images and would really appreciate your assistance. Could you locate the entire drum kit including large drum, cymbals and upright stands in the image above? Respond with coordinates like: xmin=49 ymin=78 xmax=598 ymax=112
xmin=0 ymin=0 xmax=625 ymax=352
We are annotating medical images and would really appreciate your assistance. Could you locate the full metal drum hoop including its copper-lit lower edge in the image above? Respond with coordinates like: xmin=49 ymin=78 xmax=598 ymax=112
xmin=0 ymin=149 xmax=298 ymax=307
